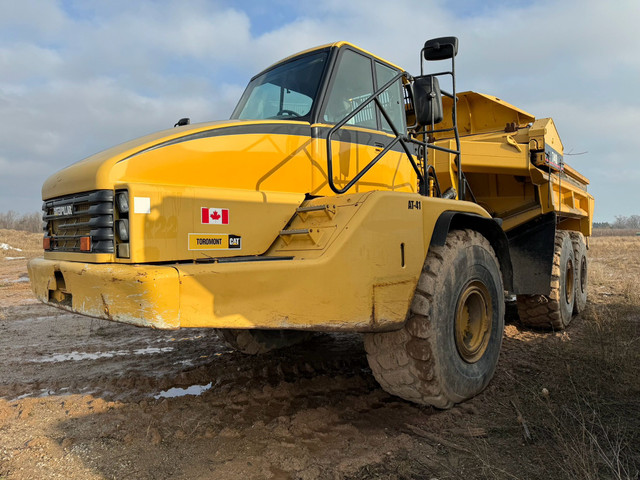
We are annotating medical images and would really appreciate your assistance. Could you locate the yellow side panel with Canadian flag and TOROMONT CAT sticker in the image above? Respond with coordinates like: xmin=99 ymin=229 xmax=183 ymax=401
xmin=119 ymin=184 xmax=304 ymax=263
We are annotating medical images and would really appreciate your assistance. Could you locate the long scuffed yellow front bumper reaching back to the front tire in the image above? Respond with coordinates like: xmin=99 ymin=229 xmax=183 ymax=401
xmin=29 ymin=258 xmax=415 ymax=332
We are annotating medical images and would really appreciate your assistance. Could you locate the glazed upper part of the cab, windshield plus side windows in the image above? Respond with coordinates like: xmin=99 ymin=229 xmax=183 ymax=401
xmin=231 ymin=42 xmax=406 ymax=133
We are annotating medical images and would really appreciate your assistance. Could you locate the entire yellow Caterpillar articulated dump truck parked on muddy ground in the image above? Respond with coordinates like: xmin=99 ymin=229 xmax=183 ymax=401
xmin=29 ymin=37 xmax=594 ymax=408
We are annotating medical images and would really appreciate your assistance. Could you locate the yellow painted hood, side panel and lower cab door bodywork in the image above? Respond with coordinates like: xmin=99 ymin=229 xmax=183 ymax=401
xmin=43 ymin=121 xmax=416 ymax=263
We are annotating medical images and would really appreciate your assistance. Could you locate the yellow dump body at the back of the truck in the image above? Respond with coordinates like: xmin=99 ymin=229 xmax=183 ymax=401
xmin=430 ymin=92 xmax=594 ymax=236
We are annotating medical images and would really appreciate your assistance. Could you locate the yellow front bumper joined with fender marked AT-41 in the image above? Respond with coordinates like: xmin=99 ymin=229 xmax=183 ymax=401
xmin=29 ymin=191 xmax=486 ymax=331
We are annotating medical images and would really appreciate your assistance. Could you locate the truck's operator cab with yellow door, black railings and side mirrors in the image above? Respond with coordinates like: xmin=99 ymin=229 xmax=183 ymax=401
xmin=231 ymin=37 xmax=460 ymax=199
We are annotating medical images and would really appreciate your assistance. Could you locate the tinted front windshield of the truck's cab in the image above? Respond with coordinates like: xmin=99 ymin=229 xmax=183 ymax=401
xmin=231 ymin=51 xmax=329 ymax=120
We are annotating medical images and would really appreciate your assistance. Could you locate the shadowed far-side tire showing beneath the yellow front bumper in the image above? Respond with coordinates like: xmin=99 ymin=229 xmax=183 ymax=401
xmin=216 ymin=328 xmax=313 ymax=355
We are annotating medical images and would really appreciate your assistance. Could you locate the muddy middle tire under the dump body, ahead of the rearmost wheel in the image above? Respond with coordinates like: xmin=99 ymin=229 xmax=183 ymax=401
xmin=517 ymin=230 xmax=576 ymax=330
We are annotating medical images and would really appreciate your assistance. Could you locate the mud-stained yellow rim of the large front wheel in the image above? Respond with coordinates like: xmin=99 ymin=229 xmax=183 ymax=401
xmin=455 ymin=281 xmax=493 ymax=363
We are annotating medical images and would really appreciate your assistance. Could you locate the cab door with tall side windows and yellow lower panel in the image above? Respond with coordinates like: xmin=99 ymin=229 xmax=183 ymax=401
xmin=313 ymin=46 xmax=416 ymax=194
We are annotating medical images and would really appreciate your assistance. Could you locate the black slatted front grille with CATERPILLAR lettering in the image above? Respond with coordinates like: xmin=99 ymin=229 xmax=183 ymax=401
xmin=42 ymin=190 xmax=114 ymax=253
